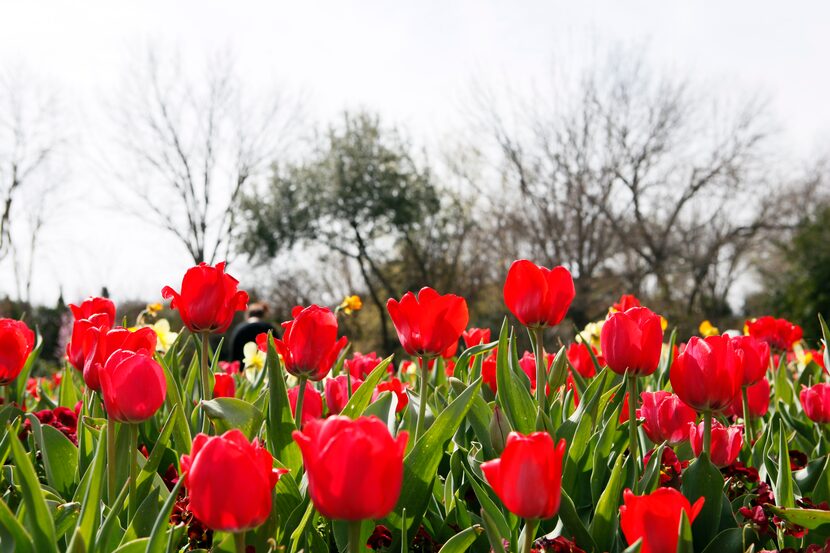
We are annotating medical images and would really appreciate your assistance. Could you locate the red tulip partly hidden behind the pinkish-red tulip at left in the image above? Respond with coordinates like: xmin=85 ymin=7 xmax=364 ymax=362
xmin=83 ymin=326 xmax=157 ymax=392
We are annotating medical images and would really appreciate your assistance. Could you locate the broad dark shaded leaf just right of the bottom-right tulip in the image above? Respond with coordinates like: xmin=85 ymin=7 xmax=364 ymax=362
xmin=683 ymin=453 xmax=724 ymax=551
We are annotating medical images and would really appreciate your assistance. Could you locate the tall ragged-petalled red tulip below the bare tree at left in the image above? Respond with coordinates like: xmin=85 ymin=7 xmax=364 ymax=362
xmin=161 ymin=262 xmax=248 ymax=334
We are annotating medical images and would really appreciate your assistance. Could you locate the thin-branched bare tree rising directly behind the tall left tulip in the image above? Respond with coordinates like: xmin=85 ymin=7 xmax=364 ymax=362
xmin=114 ymin=51 xmax=301 ymax=263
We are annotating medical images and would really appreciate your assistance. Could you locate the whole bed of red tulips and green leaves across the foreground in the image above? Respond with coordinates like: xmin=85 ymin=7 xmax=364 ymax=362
xmin=0 ymin=260 xmax=830 ymax=553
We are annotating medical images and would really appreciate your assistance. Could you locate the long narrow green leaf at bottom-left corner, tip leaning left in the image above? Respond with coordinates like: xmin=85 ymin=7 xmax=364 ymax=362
xmin=6 ymin=423 xmax=58 ymax=553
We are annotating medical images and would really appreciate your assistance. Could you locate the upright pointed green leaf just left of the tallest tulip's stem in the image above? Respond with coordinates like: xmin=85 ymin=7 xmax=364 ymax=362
xmin=496 ymin=318 xmax=536 ymax=434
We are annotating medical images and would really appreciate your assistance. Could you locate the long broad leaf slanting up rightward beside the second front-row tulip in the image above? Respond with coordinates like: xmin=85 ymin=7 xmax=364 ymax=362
xmin=389 ymin=378 xmax=481 ymax=528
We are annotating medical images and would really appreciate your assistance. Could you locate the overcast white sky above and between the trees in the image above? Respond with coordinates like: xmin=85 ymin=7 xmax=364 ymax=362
xmin=0 ymin=0 xmax=830 ymax=303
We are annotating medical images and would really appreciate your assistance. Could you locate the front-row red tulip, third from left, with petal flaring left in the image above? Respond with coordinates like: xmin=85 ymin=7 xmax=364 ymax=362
xmin=481 ymin=432 xmax=565 ymax=519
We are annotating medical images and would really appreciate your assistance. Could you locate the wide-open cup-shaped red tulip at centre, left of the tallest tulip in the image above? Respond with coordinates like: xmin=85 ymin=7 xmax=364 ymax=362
xmin=386 ymin=287 xmax=469 ymax=357
